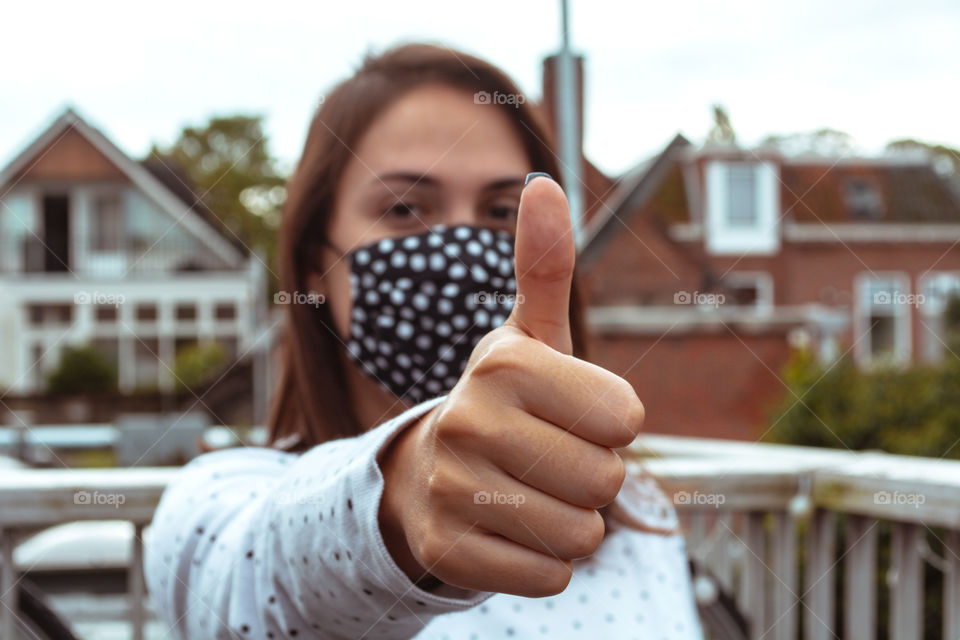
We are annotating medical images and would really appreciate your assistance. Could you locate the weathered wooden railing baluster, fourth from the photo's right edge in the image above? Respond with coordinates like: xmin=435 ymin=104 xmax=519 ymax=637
xmin=803 ymin=509 xmax=837 ymax=640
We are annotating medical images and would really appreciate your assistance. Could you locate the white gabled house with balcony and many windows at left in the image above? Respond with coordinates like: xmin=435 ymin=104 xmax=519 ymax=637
xmin=0 ymin=109 xmax=266 ymax=395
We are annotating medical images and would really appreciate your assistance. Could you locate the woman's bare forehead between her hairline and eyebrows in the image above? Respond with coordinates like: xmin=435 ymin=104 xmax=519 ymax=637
xmin=343 ymin=85 xmax=529 ymax=184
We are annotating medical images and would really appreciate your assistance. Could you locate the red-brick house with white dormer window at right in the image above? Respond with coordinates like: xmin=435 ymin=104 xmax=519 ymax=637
xmin=578 ymin=135 xmax=960 ymax=440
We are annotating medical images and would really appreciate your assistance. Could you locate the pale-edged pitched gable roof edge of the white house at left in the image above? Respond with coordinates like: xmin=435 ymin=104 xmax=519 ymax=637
xmin=0 ymin=108 xmax=244 ymax=266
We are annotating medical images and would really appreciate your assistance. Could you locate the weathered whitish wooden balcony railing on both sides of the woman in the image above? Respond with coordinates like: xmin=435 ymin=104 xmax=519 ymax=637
xmin=0 ymin=435 xmax=960 ymax=640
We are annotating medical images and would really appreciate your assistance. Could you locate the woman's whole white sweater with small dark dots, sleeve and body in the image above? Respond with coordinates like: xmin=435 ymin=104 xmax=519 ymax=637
xmin=144 ymin=397 xmax=702 ymax=640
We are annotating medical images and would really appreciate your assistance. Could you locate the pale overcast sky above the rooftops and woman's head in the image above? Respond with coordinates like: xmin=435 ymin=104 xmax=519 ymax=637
xmin=0 ymin=0 xmax=960 ymax=174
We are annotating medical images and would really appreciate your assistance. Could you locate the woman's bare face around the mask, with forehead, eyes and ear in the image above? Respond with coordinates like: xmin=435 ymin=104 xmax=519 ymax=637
xmin=310 ymin=85 xmax=533 ymax=338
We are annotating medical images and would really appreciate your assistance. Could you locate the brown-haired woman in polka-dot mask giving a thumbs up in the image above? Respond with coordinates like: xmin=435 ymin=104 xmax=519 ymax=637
xmin=146 ymin=45 xmax=701 ymax=639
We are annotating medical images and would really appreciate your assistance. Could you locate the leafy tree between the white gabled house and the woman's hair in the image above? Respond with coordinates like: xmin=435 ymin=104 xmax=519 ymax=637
xmin=145 ymin=115 xmax=286 ymax=288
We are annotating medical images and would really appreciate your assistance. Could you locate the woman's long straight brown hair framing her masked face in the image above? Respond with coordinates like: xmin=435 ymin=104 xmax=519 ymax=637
xmin=268 ymin=44 xmax=586 ymax=451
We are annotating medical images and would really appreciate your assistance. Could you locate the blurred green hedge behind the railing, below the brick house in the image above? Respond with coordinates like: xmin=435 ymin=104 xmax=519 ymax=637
xmin=768 ymin=338 xmax=960 ymax=459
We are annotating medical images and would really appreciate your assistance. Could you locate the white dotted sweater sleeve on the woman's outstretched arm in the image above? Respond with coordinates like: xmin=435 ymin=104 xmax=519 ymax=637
xmin=144 ymin=397 xmax=493 ymax=639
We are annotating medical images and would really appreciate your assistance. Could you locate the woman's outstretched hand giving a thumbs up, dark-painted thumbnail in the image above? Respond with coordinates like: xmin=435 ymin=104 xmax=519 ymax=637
xmin=380 ymin=172 xmax=644 ymax=597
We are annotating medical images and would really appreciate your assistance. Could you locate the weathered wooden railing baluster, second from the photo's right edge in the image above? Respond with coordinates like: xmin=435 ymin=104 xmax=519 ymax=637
xmin=887 ymin=522 xmax=923 ymax=640
